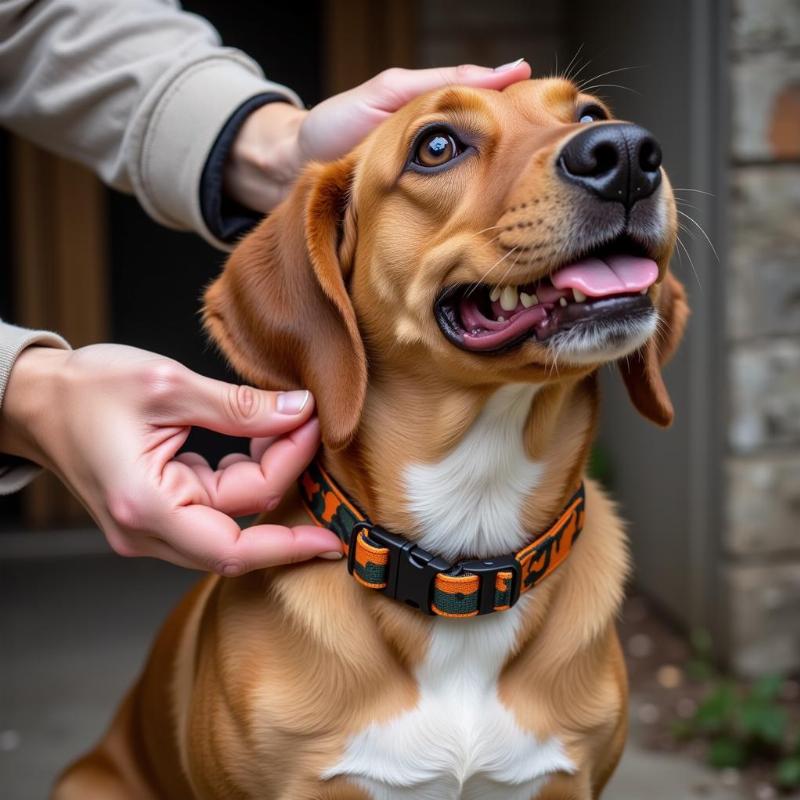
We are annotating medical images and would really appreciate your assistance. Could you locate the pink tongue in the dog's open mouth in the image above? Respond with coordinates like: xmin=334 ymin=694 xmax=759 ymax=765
xmin=551 ymin=256 xmax=658 ymax=297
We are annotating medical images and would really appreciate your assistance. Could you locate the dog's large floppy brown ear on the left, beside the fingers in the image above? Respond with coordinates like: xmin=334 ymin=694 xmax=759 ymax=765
xmin=203 ymin=160 xmax=367 ymax=449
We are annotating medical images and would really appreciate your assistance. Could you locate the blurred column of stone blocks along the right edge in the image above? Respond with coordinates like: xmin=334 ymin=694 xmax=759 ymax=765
xmin=724 ymin=0 xmax=800 ymax=674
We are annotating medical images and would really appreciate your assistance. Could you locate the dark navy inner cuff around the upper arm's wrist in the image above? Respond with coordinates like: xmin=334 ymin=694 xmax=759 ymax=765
xmin=200 ymin=92 xmax=286 ymax=245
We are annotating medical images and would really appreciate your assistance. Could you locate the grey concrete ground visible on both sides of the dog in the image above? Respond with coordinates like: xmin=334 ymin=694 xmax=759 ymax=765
xmin=0 ymin=532 xmax=743 ymax=800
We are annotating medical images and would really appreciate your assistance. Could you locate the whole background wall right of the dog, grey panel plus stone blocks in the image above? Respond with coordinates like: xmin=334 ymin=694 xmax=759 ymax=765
xmin=418 ymin=0 xmax=800 ymax=674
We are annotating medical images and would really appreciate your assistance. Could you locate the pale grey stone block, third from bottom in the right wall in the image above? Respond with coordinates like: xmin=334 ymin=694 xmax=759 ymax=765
xmin=729 ymin=339 xmax=800 ymax=453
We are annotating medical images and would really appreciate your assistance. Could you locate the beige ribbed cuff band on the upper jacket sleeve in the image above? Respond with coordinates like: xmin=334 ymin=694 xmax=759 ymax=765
xmin=131 ymin=50 xmax=302 ymax=249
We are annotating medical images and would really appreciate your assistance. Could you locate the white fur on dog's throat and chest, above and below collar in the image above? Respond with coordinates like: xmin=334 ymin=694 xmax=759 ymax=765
xmin=324 ymin=385 xmax=574 ymax=800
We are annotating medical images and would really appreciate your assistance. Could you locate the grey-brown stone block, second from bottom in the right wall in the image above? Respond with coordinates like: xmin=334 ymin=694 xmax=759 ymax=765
xmin=725 ymin=453 xmax=800 ymax=561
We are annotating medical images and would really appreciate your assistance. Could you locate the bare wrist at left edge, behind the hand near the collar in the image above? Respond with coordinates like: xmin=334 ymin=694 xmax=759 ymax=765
xmin=0 ymin=345 xmax=71 ymax=466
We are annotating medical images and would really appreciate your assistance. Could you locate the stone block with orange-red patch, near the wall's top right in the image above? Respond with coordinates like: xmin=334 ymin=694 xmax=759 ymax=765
xmin=731 ymin=50 xmax=800 ymax=161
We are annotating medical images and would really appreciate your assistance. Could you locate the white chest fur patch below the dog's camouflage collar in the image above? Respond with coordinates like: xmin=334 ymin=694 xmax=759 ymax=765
xmin=323 ymin=595 xmax=574 ymax=800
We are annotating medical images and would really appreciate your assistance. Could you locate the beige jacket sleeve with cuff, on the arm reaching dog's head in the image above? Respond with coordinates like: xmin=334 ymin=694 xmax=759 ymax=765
xmin=0 ymin=0 xmax=300 ymax=247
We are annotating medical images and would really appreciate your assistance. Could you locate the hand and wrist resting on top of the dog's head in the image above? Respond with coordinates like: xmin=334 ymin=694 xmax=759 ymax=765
xmin=225 ymin=59 xmax=531 ymax=213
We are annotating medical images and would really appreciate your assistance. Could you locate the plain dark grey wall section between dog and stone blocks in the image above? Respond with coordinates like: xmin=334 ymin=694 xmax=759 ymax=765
xmin=562 ymin=0 xmax=727 ymax=640
